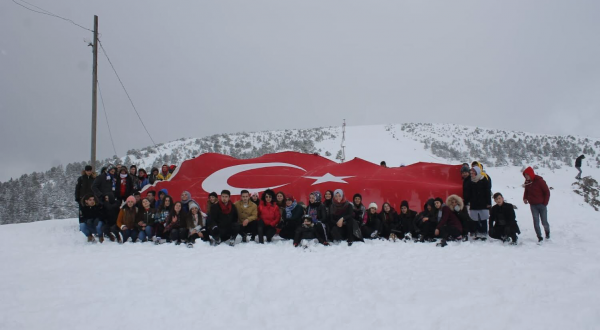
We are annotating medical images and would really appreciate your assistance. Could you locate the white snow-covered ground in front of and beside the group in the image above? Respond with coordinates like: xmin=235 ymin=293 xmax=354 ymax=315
xmin=0 ymin=167 xmax=600 ymax=330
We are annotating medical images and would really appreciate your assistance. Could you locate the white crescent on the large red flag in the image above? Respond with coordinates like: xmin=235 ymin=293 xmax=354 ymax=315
xmin=202 ymin=163 xmax=306 ymax=195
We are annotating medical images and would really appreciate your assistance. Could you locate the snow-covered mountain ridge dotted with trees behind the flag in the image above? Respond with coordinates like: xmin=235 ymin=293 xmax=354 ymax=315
xmin=0 ymin=123 xmax=600 ymax=224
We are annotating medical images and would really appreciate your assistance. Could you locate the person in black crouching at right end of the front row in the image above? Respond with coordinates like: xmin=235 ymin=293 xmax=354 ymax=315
xmin=490 ymin=193 xmax=521 ymax=245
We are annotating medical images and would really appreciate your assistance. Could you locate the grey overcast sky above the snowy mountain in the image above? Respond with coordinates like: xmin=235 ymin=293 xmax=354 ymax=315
xmin=0 ymin=0 xmax=600 ymax=181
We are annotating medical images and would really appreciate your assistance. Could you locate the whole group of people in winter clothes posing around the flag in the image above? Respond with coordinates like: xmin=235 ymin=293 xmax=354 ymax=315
xmin=75 ymin=162 xmax=550 ymax=247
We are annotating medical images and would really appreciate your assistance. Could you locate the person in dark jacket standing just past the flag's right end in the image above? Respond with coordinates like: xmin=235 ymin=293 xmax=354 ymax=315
xmin=467 ymin=166 xmax=492 ymax=240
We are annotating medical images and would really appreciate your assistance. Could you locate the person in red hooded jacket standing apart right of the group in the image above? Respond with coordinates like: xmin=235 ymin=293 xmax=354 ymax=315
xmin=523 ymin=166 xmax=550 ymax=242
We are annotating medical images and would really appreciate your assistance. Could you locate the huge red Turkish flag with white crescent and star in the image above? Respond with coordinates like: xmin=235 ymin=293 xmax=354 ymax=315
xmin=143 ymin=152 xmax=462 ymax=211
